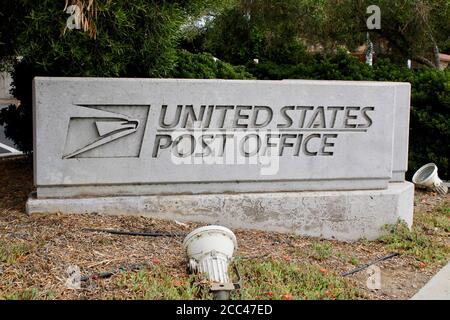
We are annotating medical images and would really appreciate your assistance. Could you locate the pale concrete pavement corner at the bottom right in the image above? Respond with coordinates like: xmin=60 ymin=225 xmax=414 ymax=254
xmin=411 ymin=262 xmax=450 ymax=300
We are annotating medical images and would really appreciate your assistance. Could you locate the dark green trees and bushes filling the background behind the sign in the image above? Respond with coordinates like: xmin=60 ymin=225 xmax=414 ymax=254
xmin=0 ymin=0 xmax=450 ymax=179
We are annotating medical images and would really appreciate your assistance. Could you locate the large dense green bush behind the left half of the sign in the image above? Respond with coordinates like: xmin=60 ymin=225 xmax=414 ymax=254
xmin=0 ymin=0 xmax=250 ymax=152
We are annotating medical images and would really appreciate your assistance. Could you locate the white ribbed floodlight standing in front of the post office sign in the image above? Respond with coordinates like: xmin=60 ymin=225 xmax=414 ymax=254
xmin=183 ymin=226 xmax=237 ymax=299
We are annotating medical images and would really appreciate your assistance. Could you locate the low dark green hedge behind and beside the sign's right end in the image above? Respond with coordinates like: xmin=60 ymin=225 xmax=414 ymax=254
xmin=248 ymin=52 xmax=450 ymax=179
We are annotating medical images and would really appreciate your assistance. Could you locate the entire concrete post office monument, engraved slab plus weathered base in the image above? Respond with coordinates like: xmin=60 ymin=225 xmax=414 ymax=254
xmin=27 ymin=77 xmax=414 ymax=240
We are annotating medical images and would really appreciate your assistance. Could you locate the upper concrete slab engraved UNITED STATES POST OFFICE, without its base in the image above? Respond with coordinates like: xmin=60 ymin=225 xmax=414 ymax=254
xmin=29 ymin=78 xmax=410 ymax=239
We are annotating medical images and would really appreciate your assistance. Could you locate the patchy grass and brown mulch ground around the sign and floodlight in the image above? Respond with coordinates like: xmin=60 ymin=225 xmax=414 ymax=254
xmin=0 ymin=159 xmax=450 ymax=300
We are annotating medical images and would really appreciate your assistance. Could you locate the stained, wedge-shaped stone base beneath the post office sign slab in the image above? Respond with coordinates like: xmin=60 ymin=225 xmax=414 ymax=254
xmin=26 ymin=182 xmax=414 ymax=241
